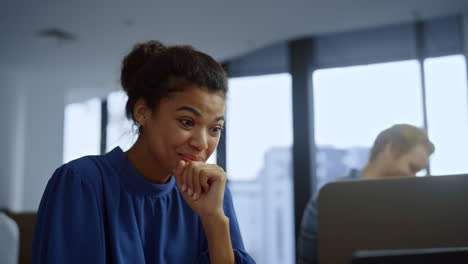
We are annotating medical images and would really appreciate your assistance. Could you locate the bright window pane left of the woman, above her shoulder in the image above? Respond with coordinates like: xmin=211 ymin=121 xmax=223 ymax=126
xmin=63 ymin=98 xmax=101 ymax=163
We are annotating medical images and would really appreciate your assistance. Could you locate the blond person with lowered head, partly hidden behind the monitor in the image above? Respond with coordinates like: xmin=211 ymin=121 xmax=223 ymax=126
xmin=297 ymin=124 xmax=435 ymax=264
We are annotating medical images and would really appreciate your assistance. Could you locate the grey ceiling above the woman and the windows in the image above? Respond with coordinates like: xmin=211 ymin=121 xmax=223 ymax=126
xmin=0 ymin=0 xmax=468 ymax=101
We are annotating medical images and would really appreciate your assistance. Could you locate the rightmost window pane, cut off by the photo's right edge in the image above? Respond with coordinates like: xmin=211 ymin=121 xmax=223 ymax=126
xmin=424 ymin=55 xmax=468 ymax=175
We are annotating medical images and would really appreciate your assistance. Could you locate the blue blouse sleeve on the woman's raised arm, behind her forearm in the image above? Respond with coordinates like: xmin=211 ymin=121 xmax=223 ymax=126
xmin=198 ymin=186 xmax=255 ymax=264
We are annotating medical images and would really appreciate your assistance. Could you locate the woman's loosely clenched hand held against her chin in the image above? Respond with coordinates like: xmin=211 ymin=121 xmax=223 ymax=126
xmin=174 ymin=160 xmax=226 ymax=219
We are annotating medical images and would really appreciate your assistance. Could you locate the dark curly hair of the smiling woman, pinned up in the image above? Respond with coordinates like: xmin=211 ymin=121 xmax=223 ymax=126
xmin=120 ymin=40 xmax=227 ymax=127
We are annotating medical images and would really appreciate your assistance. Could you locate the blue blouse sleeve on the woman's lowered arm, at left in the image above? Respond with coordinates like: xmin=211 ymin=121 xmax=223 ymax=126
xmin=31 ymin=165 xmax=106 ymax=264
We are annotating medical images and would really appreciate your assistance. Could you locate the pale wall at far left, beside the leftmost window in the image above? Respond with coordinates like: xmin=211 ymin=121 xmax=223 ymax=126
xmin=0 ymin=70 xmax=64 ymax=211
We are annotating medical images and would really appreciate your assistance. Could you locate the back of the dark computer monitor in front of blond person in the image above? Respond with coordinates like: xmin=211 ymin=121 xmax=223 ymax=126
xmin=318 ymin=175 xmax=468 ymax=264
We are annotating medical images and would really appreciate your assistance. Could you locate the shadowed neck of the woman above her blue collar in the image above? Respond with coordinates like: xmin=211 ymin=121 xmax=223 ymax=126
xmin=125 ymin=137 xmax=171 ymax=184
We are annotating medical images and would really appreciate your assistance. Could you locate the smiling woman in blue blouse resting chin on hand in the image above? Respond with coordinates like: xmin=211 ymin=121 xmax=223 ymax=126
xmin=32 ymin=41 xmax=254 ymax=264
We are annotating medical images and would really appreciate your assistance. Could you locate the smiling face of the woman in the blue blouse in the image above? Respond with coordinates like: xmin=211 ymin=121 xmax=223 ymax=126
xmin=140 ymin=86 xmax=225 ymax=176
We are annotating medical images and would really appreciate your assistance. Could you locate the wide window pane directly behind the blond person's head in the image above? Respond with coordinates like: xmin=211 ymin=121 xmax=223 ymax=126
xmin=313 ymin=60 xmax=423 ymax=188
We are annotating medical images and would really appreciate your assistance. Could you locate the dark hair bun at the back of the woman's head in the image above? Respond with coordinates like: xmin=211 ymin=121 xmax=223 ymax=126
xmin=120 ymin=40 xmax=167 ymax=94
